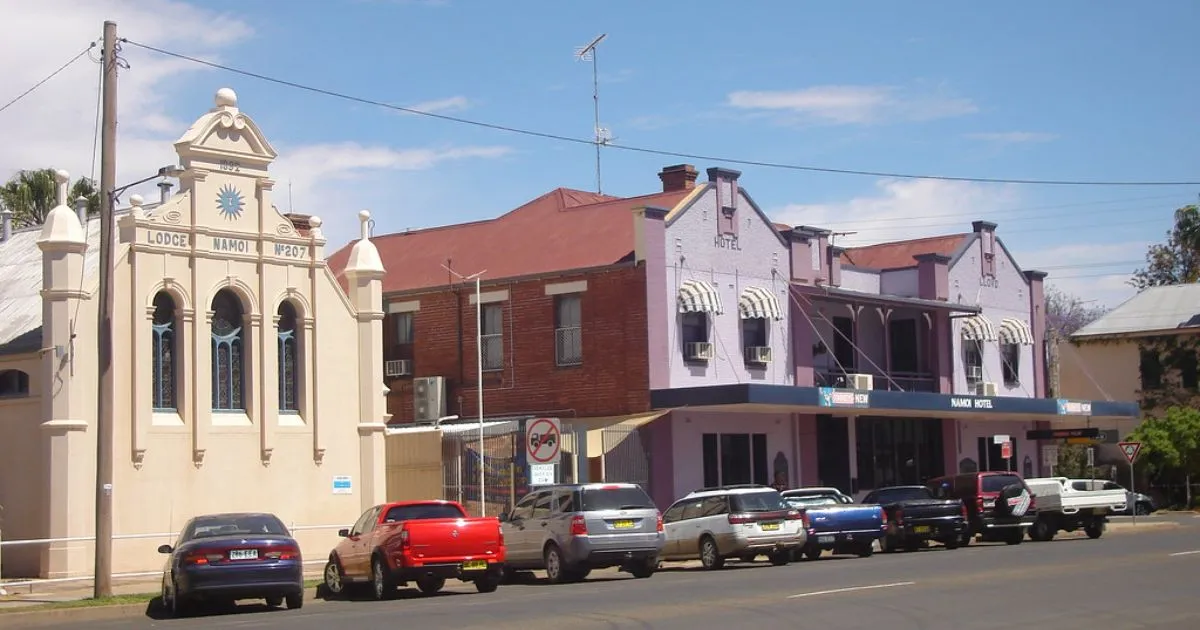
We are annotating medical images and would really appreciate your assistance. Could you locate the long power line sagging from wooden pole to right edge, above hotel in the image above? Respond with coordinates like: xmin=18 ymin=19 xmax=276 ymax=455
xmin=121 ymin=38 xmax=1200 ymax=186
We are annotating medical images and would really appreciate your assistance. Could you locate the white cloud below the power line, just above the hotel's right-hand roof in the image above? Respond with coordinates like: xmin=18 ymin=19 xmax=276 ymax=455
xmin=770 ymin=179 xmax=1018 ymax=246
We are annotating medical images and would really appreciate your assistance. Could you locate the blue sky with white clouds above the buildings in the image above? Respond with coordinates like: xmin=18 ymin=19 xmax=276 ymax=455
xmin=0 ymin=0 xmax=1200 ymax=306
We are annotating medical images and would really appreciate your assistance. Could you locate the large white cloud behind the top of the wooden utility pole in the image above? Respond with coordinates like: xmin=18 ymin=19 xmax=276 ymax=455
xmin=0 ymin=0 xmax=253 ymax=199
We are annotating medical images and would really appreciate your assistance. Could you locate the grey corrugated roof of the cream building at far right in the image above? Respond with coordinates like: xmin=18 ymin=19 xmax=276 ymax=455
xmin=1070 ymin=284 xmax=1200 ymax=338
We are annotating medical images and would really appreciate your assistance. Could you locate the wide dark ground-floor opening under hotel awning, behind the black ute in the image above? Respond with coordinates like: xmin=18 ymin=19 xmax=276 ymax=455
xmin=854 ymin=416 xmax=946 ymax=490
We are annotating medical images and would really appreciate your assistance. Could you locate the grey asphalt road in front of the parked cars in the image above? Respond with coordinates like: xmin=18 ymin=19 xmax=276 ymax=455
xmin=37 ymin=518 xmax=1200 ymax=630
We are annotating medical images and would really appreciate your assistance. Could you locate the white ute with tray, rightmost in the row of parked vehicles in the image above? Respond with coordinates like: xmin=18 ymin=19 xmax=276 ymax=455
xmin=1025 ymin=476 xmax=1128 ymax=541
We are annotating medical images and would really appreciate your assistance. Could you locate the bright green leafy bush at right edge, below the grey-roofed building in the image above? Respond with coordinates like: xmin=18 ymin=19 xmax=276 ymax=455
xmin=1126 ymin=407 xmax=1200 ymax=509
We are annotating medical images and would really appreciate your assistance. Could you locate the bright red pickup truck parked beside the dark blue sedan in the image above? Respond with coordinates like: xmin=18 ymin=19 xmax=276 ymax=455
xmin=324 ymin=500 xmax=504 ymax=600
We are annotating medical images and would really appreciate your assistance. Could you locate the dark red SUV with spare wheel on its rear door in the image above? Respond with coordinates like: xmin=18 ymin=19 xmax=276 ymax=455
xmin=925 ymin=470 xmax=1038 ymax=545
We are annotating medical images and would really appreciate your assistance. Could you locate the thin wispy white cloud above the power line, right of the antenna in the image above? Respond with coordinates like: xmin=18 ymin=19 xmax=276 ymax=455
xmin=727 ymin=85 xmax=979 ymax=125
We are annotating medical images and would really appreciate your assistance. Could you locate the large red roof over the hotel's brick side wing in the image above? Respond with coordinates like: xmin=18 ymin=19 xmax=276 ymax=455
xmin=329 ymin=188 xmax=692 ymax=293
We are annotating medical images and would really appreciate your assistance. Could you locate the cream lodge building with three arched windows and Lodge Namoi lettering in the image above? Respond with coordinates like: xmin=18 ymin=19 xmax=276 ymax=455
xmin=0 ymin=89 xmax=386 ymax=577
